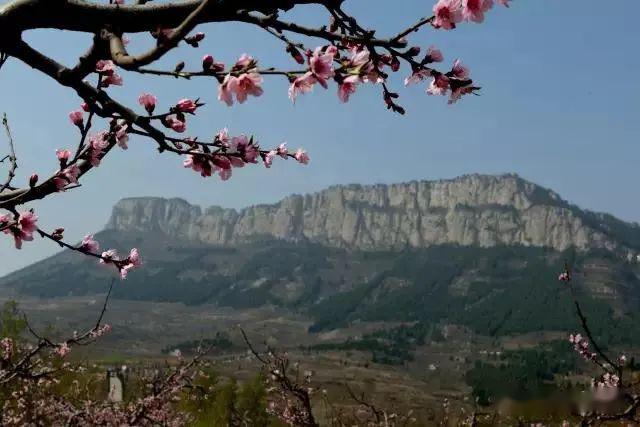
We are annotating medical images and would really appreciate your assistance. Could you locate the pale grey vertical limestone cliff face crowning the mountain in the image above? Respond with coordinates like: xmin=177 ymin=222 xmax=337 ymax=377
xmin=107 ymin=175 xmax=636 ymax=250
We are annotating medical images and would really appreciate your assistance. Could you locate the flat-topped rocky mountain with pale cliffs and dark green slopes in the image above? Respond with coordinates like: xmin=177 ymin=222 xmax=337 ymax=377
xmin=0 ymin=175 xmax=640 ymax=343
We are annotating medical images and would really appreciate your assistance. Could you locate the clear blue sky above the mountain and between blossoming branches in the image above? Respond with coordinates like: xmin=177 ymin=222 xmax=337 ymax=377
xmin=0 ymin=0 xmax=640 ymax=274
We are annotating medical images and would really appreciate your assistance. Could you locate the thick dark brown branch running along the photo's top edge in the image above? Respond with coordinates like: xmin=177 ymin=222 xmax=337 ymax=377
xmin=0 ymin=0 xmax=404 ymax=47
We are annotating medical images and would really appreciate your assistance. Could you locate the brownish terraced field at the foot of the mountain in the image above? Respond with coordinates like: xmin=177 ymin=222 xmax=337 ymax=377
xmin=0 ymin=290 xmax=596 ymax=424
